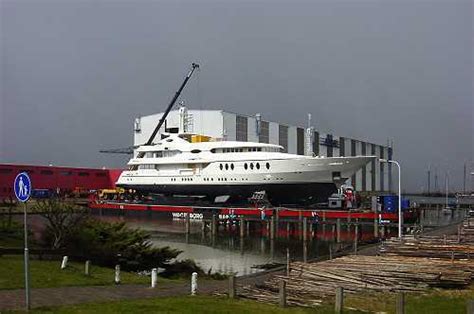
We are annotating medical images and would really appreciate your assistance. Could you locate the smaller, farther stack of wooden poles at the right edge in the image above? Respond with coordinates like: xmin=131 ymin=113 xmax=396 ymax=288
xmin=379 ymin=236 xmax=474 ymax=259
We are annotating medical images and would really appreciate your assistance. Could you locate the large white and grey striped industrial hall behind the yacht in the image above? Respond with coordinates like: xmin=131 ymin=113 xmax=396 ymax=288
xmin=134 ymin=107 xmax=393 ymax=192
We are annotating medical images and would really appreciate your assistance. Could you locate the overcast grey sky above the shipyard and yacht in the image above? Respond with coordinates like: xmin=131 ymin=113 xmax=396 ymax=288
xmin=0 ymin=0 xmax=474 ymax=192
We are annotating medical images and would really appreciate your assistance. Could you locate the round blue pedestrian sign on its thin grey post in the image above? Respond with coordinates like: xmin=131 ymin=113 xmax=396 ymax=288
xmin=13 ymin=172 xmax=32 ymax=311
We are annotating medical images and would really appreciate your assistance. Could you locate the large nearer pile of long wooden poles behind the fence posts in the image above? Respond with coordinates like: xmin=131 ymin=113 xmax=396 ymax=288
xmin=242 ymin=255 xmax=473 ymax=306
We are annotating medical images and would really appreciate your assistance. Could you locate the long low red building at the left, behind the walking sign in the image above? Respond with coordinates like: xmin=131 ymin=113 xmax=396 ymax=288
xmin=0 ymin=164 xmax=122 ymax=200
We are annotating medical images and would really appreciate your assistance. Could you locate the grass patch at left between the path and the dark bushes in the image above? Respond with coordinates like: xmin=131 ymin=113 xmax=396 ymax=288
xmin=0 ymin=255 xmax=176 ymax=290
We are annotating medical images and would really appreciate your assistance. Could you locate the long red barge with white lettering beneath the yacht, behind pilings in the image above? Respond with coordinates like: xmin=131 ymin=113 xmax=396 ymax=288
xmin=89 ymin=200 xmax=418 ymax=222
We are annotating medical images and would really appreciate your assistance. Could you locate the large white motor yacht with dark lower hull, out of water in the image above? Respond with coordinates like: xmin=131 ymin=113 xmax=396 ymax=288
xmin=116 ymin=134 xmax=376 ymax=205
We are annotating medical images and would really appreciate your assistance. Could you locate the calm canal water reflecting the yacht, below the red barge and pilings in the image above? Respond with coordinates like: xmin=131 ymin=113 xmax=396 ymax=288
xmin=95 ymin=204 xmax=465 ymax=275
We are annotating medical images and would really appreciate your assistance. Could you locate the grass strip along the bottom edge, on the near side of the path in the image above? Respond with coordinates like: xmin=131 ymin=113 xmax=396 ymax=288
xmin=7 ymin=288 xmax=474 ymax=314
